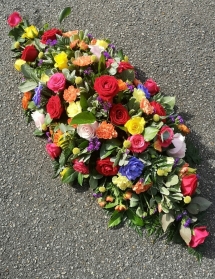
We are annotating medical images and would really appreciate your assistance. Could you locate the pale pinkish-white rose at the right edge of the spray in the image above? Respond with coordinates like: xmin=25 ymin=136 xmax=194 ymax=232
xmin=167 ymin=133 xmax=186 ymax=158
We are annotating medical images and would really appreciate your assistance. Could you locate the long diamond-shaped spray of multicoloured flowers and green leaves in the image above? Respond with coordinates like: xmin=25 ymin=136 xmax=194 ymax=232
xmin=8 ymin=8 xmax=211 ymax=258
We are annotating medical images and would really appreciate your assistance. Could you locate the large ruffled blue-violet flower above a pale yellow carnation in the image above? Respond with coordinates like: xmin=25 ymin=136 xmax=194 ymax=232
xmin=119 ymin=157 xmax=144 ymax=180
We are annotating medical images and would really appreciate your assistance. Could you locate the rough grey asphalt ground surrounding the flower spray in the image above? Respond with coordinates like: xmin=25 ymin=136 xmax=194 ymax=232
xmin=0 ymin=0 xmax=215 ymax=279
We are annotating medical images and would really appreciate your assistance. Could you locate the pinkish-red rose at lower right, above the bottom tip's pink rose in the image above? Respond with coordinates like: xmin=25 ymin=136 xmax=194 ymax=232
xmin=181 ymin=174 xmax=198 ymax=196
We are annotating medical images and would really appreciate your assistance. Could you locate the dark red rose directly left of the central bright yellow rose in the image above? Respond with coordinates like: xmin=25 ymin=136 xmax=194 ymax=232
xmin=110 ymin=104 xmax=130 ymax=125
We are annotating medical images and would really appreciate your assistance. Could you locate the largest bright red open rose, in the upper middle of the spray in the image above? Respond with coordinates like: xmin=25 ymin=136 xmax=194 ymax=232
xmin=94 ymin=75 xmax=119 ymax=101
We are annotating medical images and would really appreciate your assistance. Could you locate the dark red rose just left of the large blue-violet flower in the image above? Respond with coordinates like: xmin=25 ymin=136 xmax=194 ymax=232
xmin=96 ymin=157 xmax=119 ymax=176
